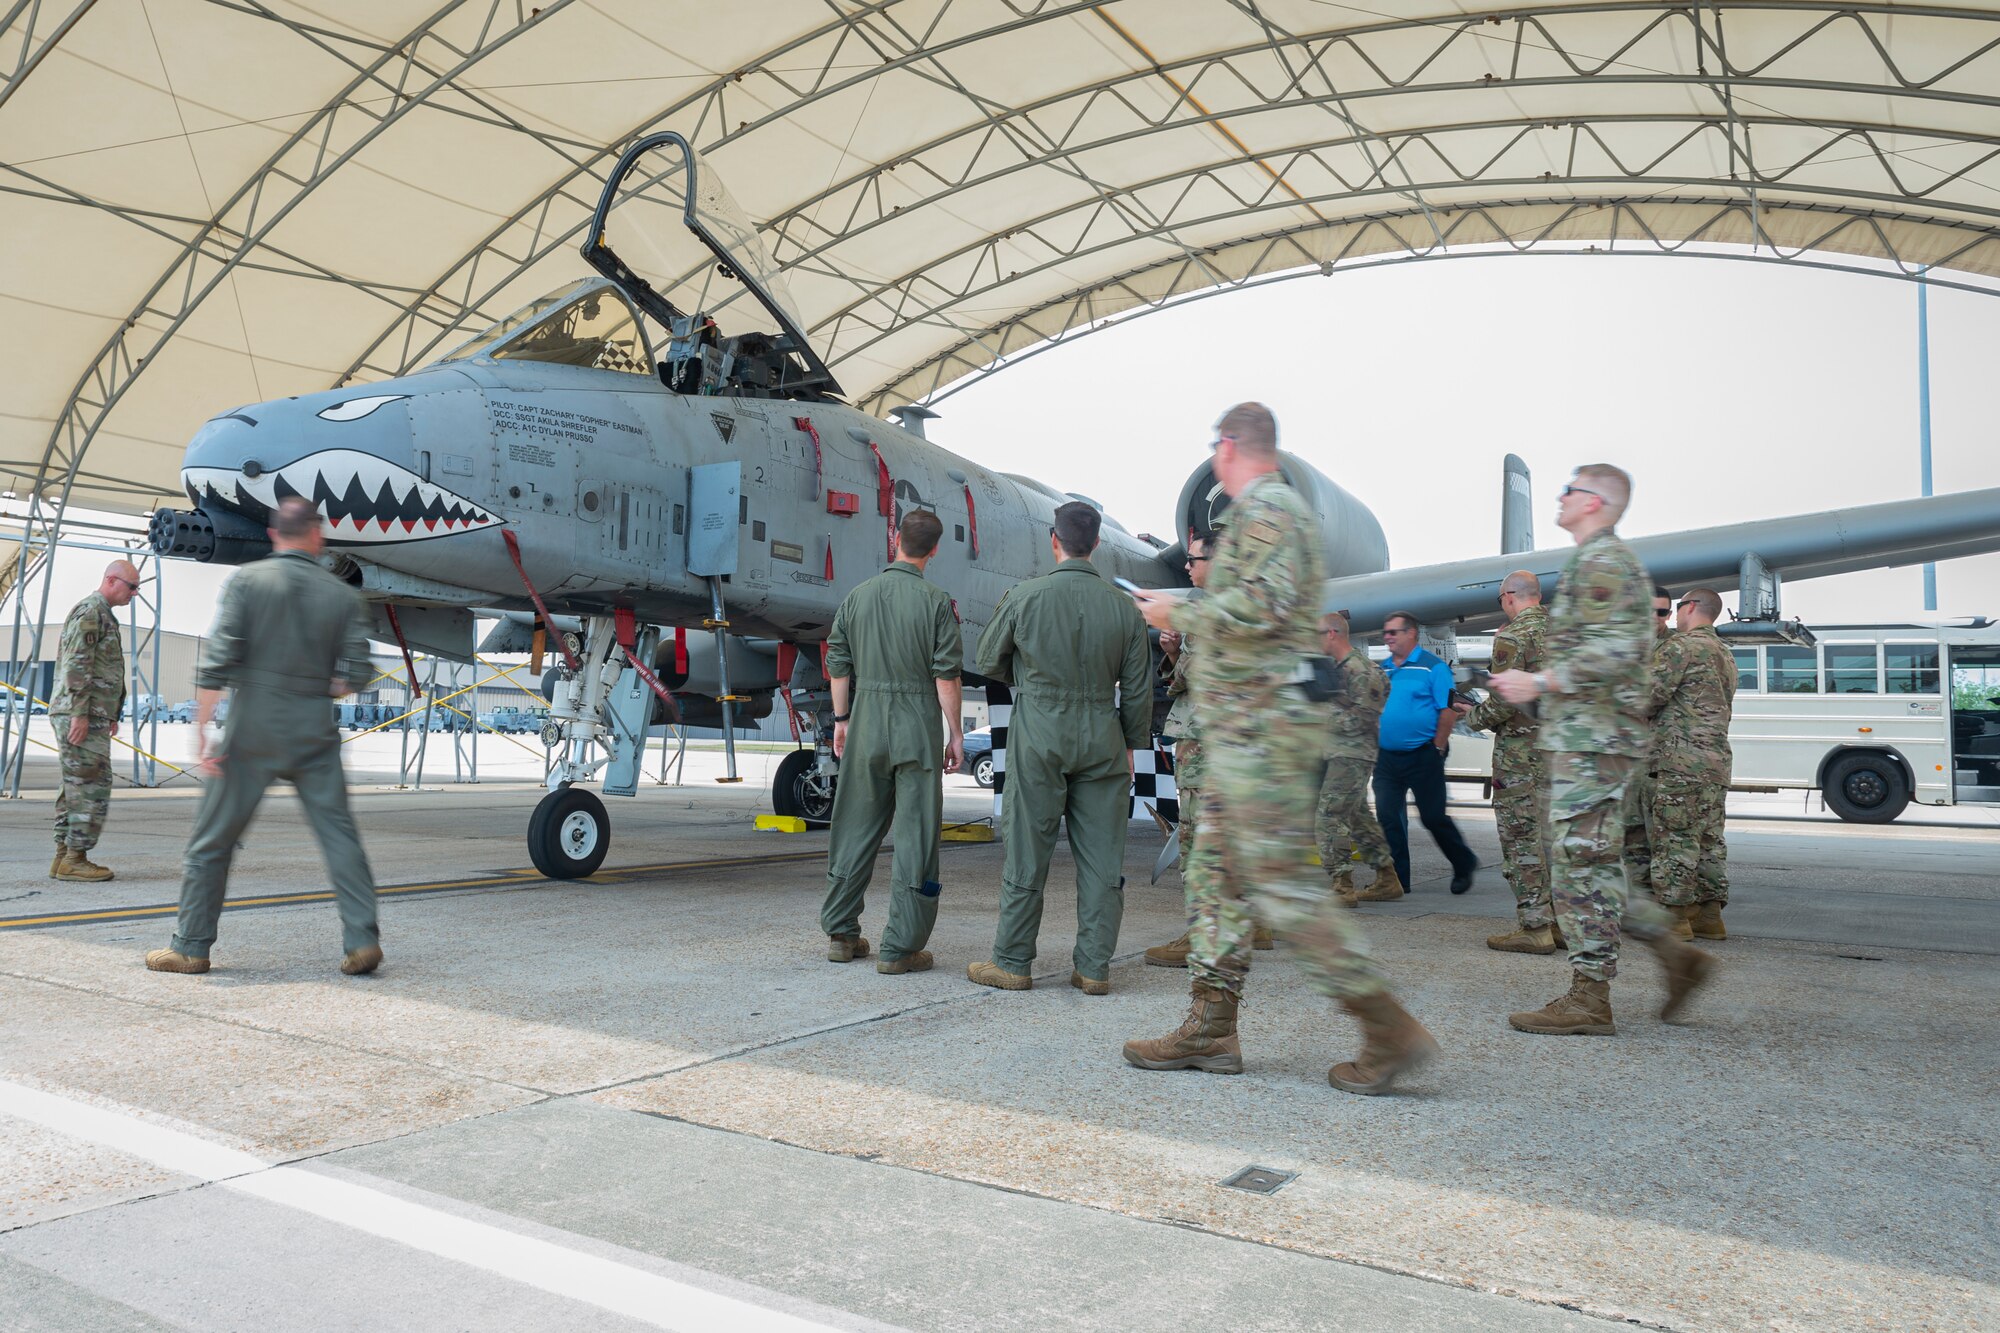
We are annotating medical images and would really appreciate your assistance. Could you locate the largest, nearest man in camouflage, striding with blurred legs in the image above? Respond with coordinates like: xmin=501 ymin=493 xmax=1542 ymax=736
xmin=1124 ymin=402 xmax=1436 ymax=1093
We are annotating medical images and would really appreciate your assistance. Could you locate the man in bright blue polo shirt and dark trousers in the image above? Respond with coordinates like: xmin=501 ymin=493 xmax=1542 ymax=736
xmin=1360 ymin=610 xmax=1480 ymax=899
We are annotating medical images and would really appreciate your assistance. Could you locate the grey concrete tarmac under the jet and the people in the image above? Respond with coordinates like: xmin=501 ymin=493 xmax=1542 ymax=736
xmin=0 ymin=757 xmax=2000 ymax=1331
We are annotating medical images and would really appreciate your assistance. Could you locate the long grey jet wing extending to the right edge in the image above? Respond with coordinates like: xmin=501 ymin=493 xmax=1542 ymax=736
xmin=1326 ymin=486 xmax=2000 ymax=630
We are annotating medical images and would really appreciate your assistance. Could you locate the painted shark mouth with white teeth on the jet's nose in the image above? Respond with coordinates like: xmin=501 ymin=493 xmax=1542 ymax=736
xmin=180 ymin=448 xmax=500 ymax=544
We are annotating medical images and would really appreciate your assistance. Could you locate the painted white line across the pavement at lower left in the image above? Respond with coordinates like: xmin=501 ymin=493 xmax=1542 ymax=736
xmin=0 ymin=1079 xmax=834 ymax=1333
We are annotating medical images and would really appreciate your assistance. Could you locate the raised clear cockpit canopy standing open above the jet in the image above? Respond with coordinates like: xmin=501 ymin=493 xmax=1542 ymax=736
xmin=584 ymin=134 xmax=832 ymax=394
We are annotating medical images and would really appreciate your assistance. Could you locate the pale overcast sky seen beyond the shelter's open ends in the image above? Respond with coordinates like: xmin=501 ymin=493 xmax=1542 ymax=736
xmin=8 ymin=256 xmax=2000 ymax=632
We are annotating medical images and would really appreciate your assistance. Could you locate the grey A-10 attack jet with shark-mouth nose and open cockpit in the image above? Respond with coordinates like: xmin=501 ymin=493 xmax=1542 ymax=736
xmin=152 ymin=134 xmax=2000 ymax=879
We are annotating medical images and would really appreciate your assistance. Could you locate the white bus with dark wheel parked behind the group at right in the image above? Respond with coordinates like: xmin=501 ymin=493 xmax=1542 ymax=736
xmin=1446 ymin=616 xmax=2000 ymax=825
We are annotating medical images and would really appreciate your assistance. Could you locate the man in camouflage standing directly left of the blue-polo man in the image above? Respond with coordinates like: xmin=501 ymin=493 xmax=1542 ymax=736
xmin=1314 ymin=610 xmax=1402 ymax=907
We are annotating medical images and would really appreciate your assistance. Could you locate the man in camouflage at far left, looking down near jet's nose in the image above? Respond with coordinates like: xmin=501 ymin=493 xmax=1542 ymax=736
xmin=48 ymin=560 xmax=138 ymax=883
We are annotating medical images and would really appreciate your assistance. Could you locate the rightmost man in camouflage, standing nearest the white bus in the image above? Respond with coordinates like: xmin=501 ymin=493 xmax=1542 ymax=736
xmin=1648 ymin=588 xmax=1736 ymax=939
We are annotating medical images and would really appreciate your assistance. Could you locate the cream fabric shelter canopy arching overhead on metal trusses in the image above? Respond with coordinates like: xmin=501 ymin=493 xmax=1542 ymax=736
xmin=0 ymin=0 xmax=2000 ymax=512
